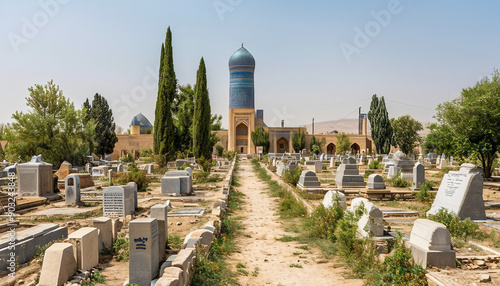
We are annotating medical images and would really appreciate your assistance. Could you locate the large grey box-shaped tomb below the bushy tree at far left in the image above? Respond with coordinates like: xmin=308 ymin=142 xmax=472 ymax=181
xmin=17 ymin=156 xmax=54 ymax=197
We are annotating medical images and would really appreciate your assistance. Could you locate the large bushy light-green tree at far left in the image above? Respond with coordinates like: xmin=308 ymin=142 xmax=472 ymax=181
xmin=5 ymin=80 xmax=95 ymax=165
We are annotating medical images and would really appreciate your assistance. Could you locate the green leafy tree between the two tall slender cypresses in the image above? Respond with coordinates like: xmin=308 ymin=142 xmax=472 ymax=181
xmin=174 ymin=84 xmax=194 ymax=152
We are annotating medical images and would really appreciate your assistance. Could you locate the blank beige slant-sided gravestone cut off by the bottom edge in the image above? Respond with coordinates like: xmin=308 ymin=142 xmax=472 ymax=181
xmin=38 ymin=243 xmax=77 ymax=286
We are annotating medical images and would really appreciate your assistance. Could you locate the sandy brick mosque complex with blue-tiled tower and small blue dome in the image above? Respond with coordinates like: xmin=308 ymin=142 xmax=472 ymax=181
xmin=111 ymin=45 xmax=374 ymax=160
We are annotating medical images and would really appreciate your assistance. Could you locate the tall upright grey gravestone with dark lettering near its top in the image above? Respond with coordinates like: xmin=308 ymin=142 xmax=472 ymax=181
xmin=128 ymin=218 xmax=160 ymax=286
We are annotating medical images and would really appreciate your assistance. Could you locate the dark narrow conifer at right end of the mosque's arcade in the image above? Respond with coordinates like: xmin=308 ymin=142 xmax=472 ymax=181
xmin=368 ymin=94 xmax=393 ymax=154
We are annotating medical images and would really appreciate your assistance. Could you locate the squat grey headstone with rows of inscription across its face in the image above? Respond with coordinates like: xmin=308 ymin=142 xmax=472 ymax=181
xmin=102 ymin=186 xmax=134 ymax=217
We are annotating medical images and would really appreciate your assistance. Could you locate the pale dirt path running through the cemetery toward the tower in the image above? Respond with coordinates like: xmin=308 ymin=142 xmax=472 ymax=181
xmin=228 ymin=160 xmax=363 ymax=286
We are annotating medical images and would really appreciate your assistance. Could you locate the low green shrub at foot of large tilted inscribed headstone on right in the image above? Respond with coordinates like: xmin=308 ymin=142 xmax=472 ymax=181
xmin=429 ymin=208 xmax=486 ymax=240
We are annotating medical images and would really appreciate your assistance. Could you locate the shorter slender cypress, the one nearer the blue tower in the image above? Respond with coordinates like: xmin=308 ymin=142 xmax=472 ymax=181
xmin=193 ymin=57 xmax=212 ymax=159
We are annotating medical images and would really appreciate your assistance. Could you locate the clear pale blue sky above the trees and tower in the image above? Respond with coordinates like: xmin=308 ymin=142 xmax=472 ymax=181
xmin=0 ymin=0 xmax=500 ymax=129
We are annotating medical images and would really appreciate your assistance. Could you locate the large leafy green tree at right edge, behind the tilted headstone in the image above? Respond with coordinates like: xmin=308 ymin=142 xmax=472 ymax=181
xmin=435 ymin=70 xmax=500 ymax=178
